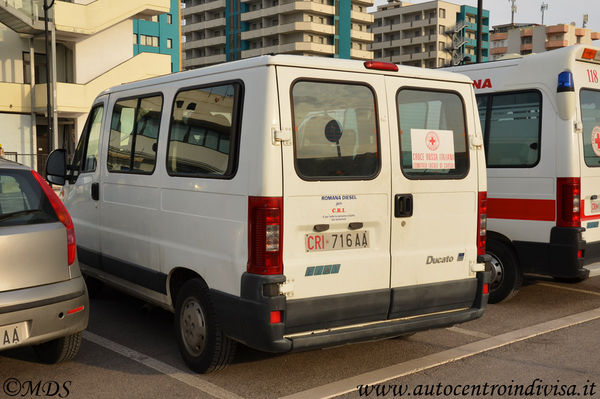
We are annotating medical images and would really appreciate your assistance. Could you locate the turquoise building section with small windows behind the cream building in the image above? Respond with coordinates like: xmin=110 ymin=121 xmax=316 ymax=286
xmin=133 ymin=0 xmax=181 ymax=72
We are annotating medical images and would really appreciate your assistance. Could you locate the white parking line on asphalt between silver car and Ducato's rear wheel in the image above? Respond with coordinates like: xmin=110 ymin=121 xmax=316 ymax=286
xmin=83 ymin=331 xmax=243 ymax=399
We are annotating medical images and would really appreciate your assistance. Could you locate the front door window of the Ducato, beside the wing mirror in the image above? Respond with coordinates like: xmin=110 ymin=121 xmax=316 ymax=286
xmin=71 ymin=105 xmax=104 ymax=177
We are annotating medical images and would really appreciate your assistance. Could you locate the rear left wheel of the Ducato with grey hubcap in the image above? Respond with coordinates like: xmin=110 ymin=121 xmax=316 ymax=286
xmin=175 ymin=279 xmax=236 ymax=373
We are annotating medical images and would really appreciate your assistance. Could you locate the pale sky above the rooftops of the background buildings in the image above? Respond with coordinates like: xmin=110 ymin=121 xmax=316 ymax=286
xmin=375 ymin=0 xmax=600 ymax=32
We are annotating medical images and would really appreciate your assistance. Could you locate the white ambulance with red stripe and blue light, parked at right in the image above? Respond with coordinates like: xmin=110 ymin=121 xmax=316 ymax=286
xmin=450 ymin=46 xmax=600 ymax=302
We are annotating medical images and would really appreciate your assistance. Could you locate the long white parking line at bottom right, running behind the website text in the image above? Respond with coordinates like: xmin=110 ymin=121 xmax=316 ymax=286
xmin=282 ymin=308 xmax=600 ymax=399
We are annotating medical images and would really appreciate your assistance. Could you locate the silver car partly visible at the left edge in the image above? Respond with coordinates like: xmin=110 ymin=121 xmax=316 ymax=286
xmin=0 ymin=157 xmax=89 ymax=363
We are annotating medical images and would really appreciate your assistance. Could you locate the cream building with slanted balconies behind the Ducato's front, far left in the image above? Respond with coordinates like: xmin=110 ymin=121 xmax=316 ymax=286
xmin=0 ymin=0 xmax=173 ymax=169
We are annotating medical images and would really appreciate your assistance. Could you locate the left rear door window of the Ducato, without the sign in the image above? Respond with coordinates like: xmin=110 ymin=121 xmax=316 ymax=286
xmin=292 ymin=81 xmax=380 ymax=180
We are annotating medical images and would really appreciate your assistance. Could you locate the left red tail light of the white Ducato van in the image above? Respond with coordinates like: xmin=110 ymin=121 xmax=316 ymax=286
xmin=247 ymin=197 xmax=283 ymax=274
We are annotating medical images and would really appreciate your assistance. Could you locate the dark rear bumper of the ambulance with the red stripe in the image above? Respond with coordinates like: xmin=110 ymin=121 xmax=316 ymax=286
xmin=513 ymin=227 xmax=600 ymax=279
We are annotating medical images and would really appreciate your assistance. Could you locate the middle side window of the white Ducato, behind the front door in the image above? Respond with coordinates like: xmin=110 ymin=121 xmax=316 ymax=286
xmin=107 ymin=95 xmax=163 ymax=174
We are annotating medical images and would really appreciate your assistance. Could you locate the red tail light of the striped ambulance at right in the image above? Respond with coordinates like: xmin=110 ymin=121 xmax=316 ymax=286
xmin=556 ymin=177 xmax=581 ymax=227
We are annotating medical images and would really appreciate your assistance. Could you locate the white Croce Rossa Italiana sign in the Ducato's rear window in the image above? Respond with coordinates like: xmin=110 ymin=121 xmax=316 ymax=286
xmin=410 ymin=129 xmax=456 ymax=169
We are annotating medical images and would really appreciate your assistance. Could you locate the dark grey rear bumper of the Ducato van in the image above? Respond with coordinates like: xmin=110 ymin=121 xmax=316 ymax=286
xmin=211 ymin=272 xmax=489 ymax=353
